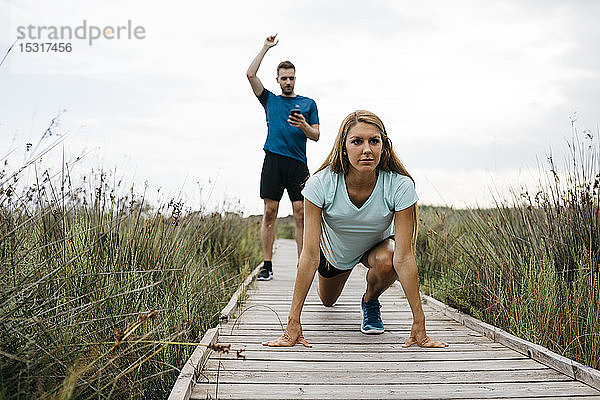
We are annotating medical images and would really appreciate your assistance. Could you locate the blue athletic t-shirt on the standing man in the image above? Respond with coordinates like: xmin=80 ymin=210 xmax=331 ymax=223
xmin=258 ymin=89 xmax=319 ymax=164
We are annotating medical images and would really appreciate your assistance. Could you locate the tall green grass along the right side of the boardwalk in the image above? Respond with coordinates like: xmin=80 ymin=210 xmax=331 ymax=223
xmin=418 ymin=128 xmax=600 ymax=368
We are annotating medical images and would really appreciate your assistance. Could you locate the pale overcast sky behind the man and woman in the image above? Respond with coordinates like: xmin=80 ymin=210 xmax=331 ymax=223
xmin=0 ymin=0 xmax=600 ymax=215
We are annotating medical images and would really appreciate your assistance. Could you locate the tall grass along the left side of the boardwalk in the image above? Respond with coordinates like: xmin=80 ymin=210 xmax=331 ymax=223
xmin=0 ymin=152 xmax=260 ymax=399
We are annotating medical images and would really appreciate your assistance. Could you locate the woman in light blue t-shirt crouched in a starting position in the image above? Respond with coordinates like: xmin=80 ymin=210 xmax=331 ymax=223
xmin=263 ymin=110 xmax=447 ymax=347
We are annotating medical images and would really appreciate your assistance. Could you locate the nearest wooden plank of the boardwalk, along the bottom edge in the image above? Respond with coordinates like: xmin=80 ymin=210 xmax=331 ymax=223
xmin=192 ymin=382 xmax=598 ymax=400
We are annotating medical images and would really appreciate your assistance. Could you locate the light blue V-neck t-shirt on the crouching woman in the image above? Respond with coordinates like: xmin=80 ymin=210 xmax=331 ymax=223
xmin=302 ymin=167 xmax=419 ymax=270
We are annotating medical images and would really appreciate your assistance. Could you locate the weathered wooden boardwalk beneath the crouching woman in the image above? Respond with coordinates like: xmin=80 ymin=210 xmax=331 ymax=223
xmin=191 ymin=241 xmax=600 ymax=399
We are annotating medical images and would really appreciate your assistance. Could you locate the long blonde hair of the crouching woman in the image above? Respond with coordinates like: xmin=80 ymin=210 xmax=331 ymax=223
xmin=317 ymin=110 xmax=419 ymax=253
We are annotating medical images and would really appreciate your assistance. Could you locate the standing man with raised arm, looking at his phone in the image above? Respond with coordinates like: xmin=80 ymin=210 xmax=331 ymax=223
xmin=246 ymin=35 xmax=319 ymax=281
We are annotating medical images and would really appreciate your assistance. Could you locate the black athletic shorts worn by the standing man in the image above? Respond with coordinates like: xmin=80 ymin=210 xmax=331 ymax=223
xmin=260 ymin=150 xmax=310 ymax=201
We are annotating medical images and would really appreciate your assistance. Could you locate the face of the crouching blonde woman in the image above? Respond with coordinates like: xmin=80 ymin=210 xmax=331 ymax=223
xmin=345 ymin=122 xmax=383 ymax=173
